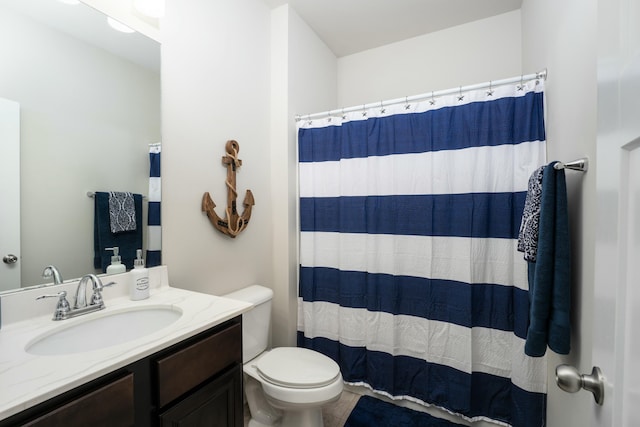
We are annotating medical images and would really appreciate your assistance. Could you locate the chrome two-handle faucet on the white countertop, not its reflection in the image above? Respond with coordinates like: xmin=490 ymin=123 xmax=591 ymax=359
xmin=36 ymin=274 xmax=116 ymax=320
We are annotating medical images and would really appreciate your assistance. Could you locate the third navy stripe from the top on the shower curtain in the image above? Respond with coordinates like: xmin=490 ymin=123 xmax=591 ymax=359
xmin=299 ymin=267 xmax=529 ymax=339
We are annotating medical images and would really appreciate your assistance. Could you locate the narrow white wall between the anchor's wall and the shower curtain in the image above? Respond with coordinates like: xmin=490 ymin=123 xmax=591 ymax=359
xmin=271 ymin=5 xmax=337 ymax=345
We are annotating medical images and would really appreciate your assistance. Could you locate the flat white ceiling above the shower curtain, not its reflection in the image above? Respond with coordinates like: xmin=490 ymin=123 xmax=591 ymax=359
xmin=264 ymin=0 xmax=522 ymax=57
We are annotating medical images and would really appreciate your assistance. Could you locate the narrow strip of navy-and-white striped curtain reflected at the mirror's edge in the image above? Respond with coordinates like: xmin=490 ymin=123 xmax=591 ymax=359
xmin=146 ymin=143 xmax=162 ymax=267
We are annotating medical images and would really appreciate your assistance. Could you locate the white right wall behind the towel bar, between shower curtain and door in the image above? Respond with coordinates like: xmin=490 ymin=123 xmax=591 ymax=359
xmin=522 ymin=0 xmax=597 ymax=426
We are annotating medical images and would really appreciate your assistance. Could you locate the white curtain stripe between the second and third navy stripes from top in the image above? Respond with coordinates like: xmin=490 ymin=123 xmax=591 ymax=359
xmin=300 ymin=232 xmax=529 ymax=291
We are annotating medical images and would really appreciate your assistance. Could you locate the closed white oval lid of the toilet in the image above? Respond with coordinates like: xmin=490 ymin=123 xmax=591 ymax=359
xmin=256 ymin=347 xmax=340 ymax=388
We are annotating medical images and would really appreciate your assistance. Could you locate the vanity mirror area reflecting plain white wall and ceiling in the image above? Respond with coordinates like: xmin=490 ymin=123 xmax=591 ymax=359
xmin=0 ymin=0 xmax=160 ymax=291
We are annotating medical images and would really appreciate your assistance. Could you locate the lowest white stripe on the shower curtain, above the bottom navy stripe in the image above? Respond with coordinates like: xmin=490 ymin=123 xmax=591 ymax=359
xmin=299 ymin=301 xmax=547 ymax=393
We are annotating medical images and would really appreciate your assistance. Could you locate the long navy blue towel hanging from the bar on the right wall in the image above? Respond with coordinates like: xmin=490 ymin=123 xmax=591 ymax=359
xmin=524 ymin=162 xmax=571 ymax=356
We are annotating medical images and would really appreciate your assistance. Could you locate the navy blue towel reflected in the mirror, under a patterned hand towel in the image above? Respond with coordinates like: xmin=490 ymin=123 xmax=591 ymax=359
xmin=93 ymin=192 xmax=142 ymax=272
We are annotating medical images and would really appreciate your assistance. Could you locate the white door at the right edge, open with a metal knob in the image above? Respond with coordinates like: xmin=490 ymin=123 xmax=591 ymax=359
xmin=592 ymin=0 xmax=640 ymax=427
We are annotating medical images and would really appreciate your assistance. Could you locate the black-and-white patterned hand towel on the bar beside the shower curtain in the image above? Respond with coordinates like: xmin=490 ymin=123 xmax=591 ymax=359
xmin=518 ymin=166 xmax=544 ymax=261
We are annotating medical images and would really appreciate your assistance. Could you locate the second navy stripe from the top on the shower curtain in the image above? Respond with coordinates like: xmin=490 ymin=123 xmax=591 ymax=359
xmin=300 ymin=191 xmax=527 ymax=239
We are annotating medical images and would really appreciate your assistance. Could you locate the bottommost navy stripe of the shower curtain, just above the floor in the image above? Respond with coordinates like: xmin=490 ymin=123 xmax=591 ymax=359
xmin=297 ymin=331 xmax=547 ymax=427
